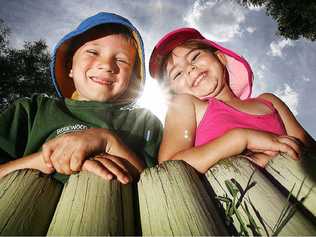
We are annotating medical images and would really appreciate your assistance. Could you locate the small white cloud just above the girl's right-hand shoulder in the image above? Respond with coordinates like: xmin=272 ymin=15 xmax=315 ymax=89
xmin=275 ymin=84 xmax=298 ymax=116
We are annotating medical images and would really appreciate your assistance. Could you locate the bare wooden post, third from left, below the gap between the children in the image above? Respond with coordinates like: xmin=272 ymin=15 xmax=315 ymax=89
xmin=138 ymin=161 xmax=228 ymax=236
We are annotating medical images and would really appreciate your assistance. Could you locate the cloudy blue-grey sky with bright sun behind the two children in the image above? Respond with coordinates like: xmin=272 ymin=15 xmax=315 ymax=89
xmin=0 ymin=0 xmax=316 ymax=138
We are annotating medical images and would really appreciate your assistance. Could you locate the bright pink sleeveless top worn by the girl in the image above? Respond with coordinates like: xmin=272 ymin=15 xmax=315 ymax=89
xmin=195 ymin=98 xmax=286 ymax=146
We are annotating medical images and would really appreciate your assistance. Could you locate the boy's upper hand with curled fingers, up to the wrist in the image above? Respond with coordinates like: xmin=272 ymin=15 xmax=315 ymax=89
xmin=42 ymin=128 xmax=111 ymax=175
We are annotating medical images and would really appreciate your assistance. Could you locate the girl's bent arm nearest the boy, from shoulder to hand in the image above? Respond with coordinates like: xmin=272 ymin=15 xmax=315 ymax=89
xmin=158 ymin=95 xmax=298 ymax=173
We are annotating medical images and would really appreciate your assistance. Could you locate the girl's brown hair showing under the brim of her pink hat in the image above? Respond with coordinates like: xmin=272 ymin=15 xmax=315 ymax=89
xmin=159 ymin=39 xmax=217 ymax=87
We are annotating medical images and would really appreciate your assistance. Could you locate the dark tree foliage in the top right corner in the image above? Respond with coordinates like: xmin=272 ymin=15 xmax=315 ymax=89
xmin=239 ymin=0 xmax=316 ymax=41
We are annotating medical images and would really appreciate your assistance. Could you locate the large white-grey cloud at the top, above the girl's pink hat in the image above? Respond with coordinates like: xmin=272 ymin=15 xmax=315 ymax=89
xmin=183 ymin=0 xmax=247 ymax=42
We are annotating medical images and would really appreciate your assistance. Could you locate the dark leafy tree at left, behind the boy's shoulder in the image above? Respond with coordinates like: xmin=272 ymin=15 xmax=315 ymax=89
xmin=0 ymin=19 xmax=54 ymax=110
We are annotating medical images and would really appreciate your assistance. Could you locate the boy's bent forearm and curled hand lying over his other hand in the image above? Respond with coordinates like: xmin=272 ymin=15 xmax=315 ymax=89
xmin=43 ymin=128 xmax=144 ymax=175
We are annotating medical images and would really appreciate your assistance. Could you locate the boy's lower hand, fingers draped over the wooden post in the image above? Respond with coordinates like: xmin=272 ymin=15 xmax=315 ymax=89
xmin=82 ymin=154 xmax=133 ymax=184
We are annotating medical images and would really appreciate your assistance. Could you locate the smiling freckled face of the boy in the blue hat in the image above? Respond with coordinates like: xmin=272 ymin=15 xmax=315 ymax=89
xmin=69 ymin=34 xmax=136 ymax=102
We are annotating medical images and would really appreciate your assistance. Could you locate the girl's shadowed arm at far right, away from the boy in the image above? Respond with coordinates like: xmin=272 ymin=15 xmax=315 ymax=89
xmin=259 ymin=93 xmax=316 ymax=149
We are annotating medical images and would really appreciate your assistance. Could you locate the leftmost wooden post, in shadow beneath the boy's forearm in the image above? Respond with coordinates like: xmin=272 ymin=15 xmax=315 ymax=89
xmin=0 ymin=170 xmax=62 ymax=235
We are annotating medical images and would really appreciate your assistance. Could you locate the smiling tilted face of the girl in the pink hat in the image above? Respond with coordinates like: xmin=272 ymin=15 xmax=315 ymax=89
xmin=165 ymin=46 xmax=226 ymax=98
